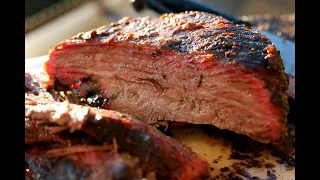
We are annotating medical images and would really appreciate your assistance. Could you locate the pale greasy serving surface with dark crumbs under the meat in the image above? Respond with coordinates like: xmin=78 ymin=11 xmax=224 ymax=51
xmin=25 ymin=56 xmax=295 ymax=180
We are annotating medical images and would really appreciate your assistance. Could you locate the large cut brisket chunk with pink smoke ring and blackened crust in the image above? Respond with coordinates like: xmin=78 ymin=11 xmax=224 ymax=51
xmin=45 ymin=12 xmax=289 ymax=143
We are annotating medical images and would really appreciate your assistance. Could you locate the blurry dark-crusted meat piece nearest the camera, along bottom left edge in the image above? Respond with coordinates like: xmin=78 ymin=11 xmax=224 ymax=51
xmin=26 ymin=152 xmax=143 ymax=180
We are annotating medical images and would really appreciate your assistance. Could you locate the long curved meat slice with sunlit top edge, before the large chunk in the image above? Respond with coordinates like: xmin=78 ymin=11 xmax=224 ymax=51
xmin=25 ymin=95 xmax=210 ymax=180
